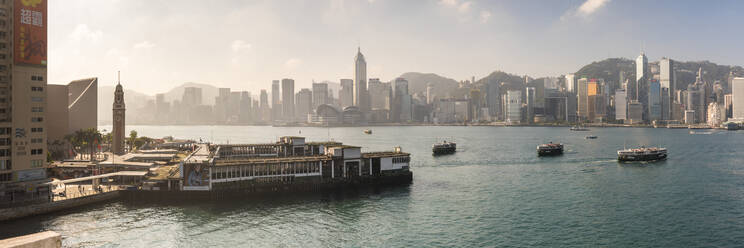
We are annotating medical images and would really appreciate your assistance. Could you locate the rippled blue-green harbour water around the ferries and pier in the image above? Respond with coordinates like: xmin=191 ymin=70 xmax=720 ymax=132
xmin=0 ymin=126 xmax=744 ymax=247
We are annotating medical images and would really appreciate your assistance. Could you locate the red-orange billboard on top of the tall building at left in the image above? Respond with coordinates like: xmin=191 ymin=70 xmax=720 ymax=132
xmin=13 ymin=0 xmax=47 ymax=66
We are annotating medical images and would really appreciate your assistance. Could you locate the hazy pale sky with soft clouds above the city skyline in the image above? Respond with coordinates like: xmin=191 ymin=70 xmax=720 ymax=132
xmin=48 ymin=0 xmax=744 ymax=95
